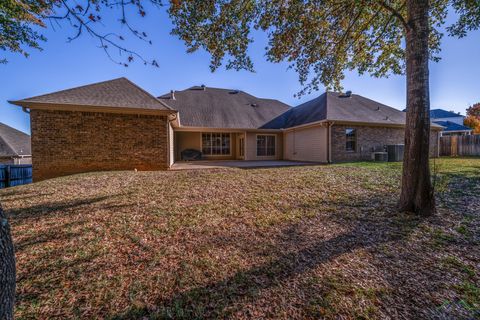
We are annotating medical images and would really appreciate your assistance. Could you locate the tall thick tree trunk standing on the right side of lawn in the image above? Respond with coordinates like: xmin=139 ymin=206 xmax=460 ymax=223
xmin=399 ymin=0 xmax=435 ymax=216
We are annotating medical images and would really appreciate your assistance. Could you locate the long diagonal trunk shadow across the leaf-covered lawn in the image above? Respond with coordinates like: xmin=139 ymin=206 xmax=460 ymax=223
xmin=109 ymin=196 xmax=422 ymax=319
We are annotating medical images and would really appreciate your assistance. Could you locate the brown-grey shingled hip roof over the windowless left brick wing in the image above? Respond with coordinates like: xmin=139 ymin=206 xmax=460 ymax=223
xmin=11 ymin=78 xmax=171 ymax=110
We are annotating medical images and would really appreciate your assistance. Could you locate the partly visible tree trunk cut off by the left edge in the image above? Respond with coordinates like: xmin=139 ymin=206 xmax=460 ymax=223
xmin=0 ymin=205 xmax=15 ymax=320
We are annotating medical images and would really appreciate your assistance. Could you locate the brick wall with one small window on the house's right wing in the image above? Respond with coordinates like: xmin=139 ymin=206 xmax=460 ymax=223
xmin=332 ymin=125 xmax=438 ymax=162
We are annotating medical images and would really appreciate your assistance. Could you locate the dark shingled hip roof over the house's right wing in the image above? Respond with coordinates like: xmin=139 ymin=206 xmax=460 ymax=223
xmin=263 ymin=92 xmax=422 ymax=128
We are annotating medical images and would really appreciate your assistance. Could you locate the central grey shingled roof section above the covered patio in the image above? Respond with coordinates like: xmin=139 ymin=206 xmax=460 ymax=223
xmin=159 ymin=86 xmax=291 ymax=129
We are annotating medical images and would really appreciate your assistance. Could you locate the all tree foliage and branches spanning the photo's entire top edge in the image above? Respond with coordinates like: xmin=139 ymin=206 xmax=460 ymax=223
xmin=0 ymin=0 xmax=480 ymax=87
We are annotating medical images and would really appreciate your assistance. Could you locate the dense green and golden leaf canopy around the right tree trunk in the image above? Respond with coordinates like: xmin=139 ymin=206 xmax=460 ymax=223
xmin=169 ymin=0 xmax=480 ymax=94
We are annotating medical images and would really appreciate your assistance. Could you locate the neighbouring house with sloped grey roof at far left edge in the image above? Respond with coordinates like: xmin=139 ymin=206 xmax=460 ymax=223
xmin=0 ymin=122 xmax=32 ymax=164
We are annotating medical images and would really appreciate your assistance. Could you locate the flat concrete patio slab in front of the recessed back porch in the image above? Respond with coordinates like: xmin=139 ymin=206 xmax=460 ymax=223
xmin=170 ymin=160 xmax=320 ymax=170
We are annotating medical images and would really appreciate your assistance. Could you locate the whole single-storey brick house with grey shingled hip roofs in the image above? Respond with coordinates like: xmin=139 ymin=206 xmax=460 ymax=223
xmin=11 ymin=78 xmax=442 ymax=180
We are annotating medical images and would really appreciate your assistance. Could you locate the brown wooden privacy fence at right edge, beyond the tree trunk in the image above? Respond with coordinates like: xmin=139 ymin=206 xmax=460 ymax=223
xmin=440 ymin=134 xmax=480 ymax=157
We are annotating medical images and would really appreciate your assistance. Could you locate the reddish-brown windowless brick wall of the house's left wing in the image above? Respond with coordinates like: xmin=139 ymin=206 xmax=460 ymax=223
xmin=30 ymin=110 xmax=168 ymax=181
